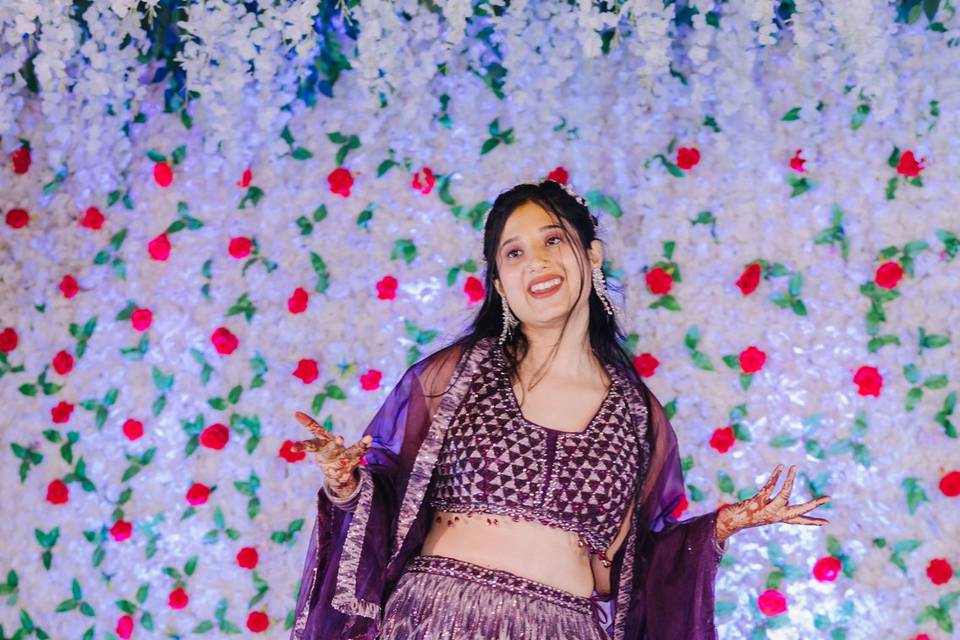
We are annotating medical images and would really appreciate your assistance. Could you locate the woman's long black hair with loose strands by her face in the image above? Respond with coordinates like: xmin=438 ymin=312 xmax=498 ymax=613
xmin=428 ymin=180 xmax=644 ymax=400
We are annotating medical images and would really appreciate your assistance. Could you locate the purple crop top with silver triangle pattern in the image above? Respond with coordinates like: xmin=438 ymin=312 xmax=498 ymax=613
xmin=428 ymin=339 xmax=645 ymax=553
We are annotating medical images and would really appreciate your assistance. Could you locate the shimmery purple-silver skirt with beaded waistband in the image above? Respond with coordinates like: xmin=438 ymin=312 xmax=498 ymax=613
xmin=377 ymin=555 xmax=608 ymax=640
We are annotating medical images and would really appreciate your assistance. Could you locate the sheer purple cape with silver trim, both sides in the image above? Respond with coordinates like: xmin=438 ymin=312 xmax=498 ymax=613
xmin=290 ymin=337 xmax=724 ymax=640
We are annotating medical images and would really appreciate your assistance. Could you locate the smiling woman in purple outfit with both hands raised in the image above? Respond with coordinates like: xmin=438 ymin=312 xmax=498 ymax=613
xmin=291 ymin=180 xmax=829 ymax=640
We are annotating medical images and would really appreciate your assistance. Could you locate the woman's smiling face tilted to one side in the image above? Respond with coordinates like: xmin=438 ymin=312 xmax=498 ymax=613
xmin=494 ymin=202 xmax=603 ymax=328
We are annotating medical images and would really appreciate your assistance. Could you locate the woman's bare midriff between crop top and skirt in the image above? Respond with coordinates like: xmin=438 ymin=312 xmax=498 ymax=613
xmin=420 ymin=511 xmax=594 ymax=597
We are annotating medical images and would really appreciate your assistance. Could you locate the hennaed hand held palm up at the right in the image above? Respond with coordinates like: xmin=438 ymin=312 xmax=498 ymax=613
xmin=717 ymin=464 xmax=830 ymax=544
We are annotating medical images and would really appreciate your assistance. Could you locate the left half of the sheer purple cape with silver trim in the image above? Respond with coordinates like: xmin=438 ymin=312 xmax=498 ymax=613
xmin=290 ymin=345 xmax=470 ymax=640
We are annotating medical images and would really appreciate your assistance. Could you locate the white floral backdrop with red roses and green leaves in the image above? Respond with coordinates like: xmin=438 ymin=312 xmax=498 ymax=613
xmin=0 ymin=0 xmax=960 ymax=640
